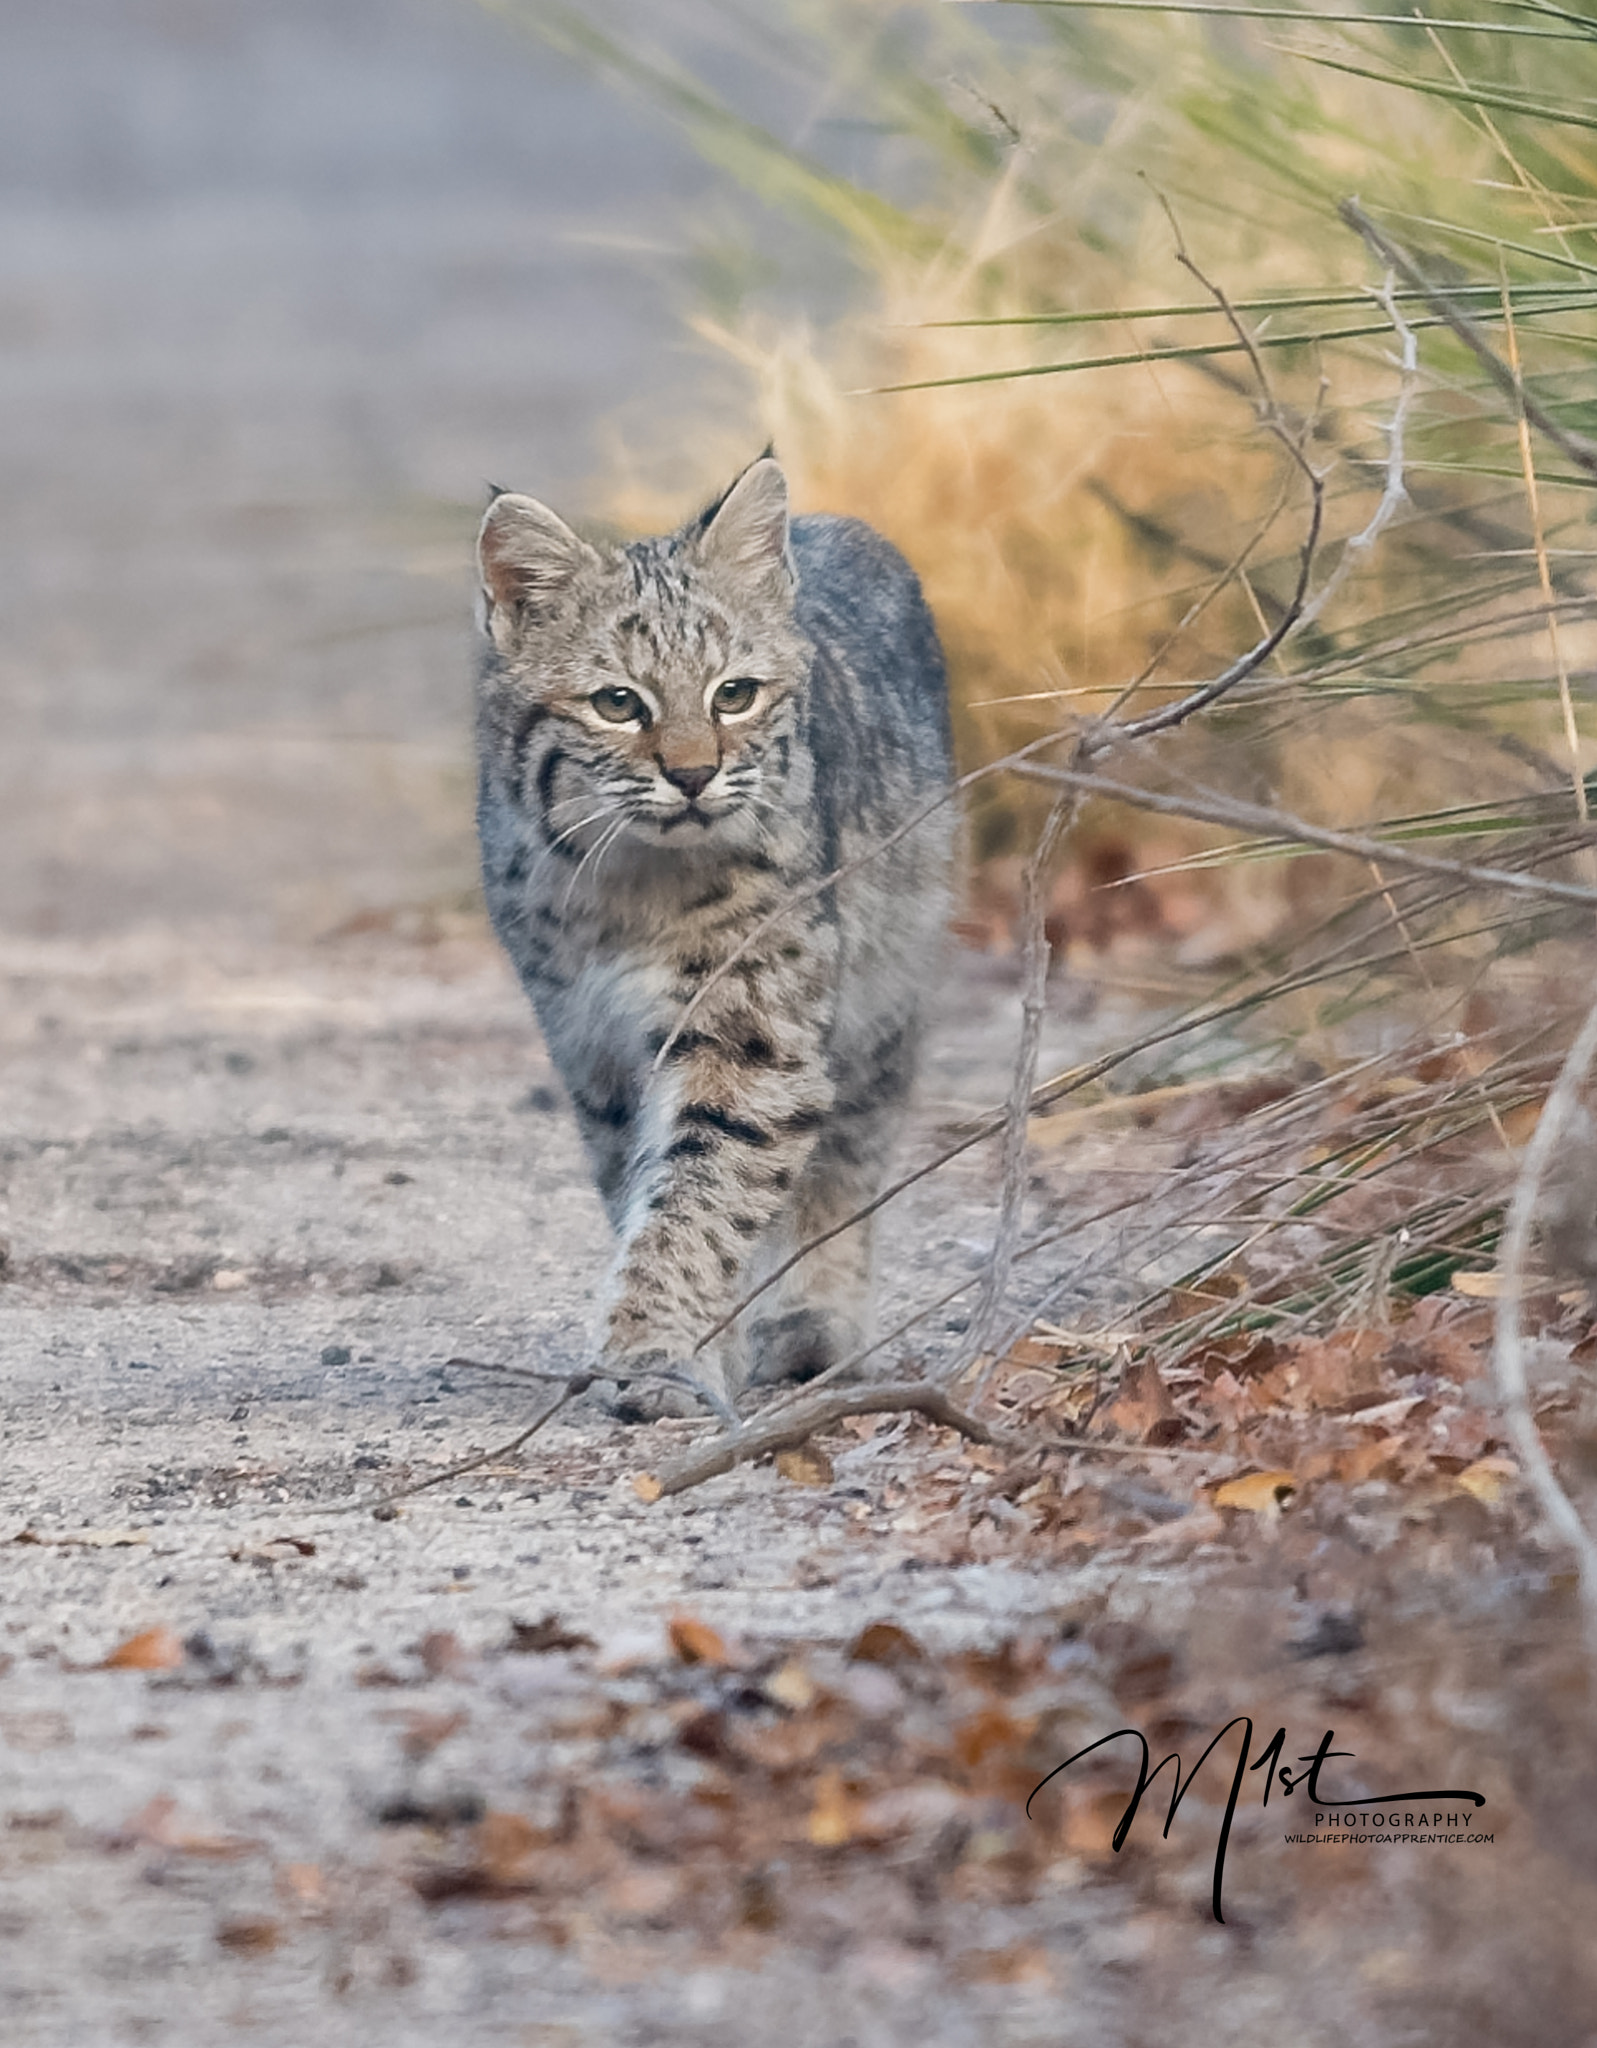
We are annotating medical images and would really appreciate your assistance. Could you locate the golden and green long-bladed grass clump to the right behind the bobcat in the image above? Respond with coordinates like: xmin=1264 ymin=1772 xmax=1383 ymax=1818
xmin=489 ymin=0 xmax=1597 ymax=1343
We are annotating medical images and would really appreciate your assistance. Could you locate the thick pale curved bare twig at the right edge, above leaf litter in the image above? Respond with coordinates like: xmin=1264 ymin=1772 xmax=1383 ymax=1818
xmin=1493 ymin=1004 xmax=1597 ymax=1655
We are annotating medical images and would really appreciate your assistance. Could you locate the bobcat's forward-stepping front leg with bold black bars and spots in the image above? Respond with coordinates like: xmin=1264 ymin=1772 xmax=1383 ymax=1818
xmin=602 ymin=930 xmax=833 ymax=1415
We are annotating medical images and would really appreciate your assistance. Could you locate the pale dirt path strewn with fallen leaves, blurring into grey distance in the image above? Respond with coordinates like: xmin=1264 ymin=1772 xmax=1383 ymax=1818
xmin=0 ymin=0 xmax=1597 ymax=2048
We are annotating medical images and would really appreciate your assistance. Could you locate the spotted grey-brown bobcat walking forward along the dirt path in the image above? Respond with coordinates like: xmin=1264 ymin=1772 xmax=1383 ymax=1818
xmin=477 ymin=453 xmax=954 ymax=1419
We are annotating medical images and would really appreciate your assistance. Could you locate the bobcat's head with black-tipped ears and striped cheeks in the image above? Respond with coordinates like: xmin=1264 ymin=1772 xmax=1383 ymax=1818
xmin=477 ymin=455 xmax=813 ymax=858
